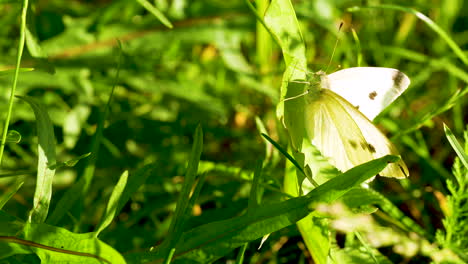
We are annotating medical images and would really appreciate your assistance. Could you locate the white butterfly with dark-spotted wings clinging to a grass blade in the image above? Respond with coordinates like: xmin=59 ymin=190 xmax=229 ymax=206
xmin=304 ymin=67 xmax=410 ymax=178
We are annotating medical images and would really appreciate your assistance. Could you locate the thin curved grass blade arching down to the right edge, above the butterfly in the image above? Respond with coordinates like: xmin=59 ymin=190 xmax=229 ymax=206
xmin=346 ymin=5 xmax=468 ymax=65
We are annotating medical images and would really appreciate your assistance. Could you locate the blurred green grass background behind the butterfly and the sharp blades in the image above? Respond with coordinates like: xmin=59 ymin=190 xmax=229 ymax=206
xmin=0 ymin=0 xmax=468 ymax=263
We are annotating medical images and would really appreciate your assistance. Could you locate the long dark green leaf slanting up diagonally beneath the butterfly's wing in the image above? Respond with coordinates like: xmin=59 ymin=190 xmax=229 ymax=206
xmin=127 ymin=156 xmax=398 ymax=263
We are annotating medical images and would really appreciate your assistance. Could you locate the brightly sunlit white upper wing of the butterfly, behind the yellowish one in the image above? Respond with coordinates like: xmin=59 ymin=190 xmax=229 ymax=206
xmin=328 ymin=67 xmax=410 ymax=120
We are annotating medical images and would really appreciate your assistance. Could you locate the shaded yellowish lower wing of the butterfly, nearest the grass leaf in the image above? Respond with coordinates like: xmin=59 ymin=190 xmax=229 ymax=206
xmin=305 ymin=89 xmax=409 ymax=178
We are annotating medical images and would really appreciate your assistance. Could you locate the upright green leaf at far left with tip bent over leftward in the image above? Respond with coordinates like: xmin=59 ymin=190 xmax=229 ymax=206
xmin=18 ymin=96 xmax=56 ymax=223
